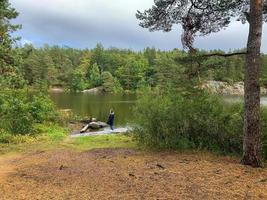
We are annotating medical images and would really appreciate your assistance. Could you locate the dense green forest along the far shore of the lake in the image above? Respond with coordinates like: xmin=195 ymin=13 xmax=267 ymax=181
xmin=1 ymin=43 xmax=267 ymax=93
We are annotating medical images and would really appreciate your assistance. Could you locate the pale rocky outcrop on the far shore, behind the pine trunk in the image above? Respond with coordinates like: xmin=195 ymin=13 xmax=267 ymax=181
xmin=201 ymin=81 xmax=267 ymax=95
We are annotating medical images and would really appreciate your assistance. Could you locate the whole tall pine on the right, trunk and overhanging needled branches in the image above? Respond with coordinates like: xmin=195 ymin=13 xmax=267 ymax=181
xmin=136 ymin=0 xmax=267 ymax=167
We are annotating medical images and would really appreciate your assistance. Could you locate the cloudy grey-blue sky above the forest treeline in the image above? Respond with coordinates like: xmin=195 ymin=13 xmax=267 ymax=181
xmin=10 ymin=0 xmax=267 ymax=53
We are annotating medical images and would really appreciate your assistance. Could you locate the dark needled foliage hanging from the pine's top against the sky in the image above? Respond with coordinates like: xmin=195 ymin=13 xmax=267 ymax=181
xmin=136 ymin=0 xmax=267 ymax=50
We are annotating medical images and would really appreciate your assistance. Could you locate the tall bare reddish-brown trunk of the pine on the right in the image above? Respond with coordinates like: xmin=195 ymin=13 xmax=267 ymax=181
xmin=242 ymin=0 xmax=263 ymax=167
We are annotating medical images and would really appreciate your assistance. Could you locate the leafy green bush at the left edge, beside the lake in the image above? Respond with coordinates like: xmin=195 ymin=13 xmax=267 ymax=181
xmin=0 ymin=90 xmax=56 ymax=135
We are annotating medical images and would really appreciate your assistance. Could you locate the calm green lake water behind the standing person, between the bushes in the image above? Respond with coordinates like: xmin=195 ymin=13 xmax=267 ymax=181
xmin=50 ymin=93 xmax=136 ymax=126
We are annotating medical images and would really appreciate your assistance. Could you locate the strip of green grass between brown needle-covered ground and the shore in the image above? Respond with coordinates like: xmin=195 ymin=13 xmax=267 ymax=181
xmin=0 ymin=124 xmax=137 ymax=155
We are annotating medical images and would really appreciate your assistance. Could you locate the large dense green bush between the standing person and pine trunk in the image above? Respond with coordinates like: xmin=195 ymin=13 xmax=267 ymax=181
xmin=134 ymin=90 xmax=267 ymax=159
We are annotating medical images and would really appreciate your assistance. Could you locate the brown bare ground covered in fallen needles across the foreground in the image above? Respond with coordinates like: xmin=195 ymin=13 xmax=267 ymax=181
xmin=0 ymin=149 xmax=267 ymax=200
